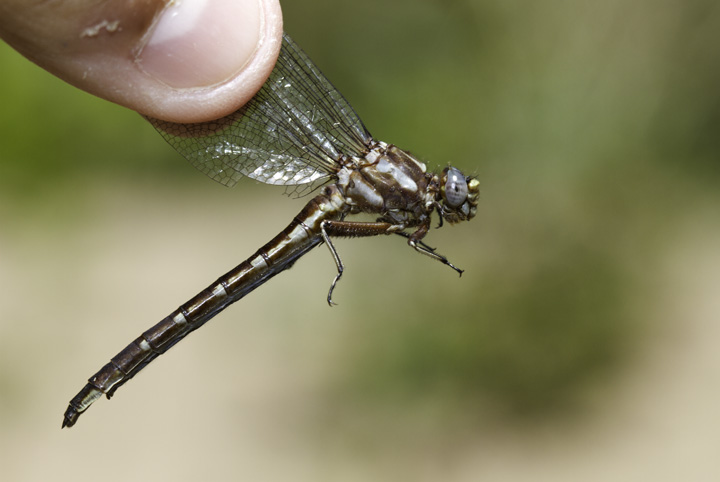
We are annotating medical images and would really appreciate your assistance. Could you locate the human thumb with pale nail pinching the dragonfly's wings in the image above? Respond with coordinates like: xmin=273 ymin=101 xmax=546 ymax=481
xmin=0 ymin=0 xmax=282 ymax=123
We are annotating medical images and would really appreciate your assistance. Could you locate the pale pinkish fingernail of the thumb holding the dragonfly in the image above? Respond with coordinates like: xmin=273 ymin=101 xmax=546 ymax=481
xmin=137 ymin=0 xmax=262 ymax=88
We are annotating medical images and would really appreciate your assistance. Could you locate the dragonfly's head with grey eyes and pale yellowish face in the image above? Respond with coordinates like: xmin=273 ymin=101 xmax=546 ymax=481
xmin=436 ymin=166 xmax=480 ymax=224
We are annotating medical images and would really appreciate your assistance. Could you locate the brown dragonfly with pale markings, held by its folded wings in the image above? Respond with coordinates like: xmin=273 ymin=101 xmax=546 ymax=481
xmin=62 ymin=34 xmax=479 ymax=428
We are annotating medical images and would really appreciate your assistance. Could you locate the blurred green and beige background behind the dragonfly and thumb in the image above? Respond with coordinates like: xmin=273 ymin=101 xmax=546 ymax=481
xmin=0 ymin=0 xmax=720 ymax=481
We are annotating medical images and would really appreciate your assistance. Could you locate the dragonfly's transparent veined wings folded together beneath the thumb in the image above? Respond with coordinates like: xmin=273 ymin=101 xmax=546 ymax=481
xmin=148 ymin=34 xmax=372 ymax=186
